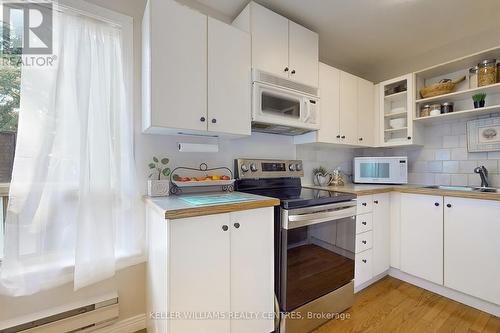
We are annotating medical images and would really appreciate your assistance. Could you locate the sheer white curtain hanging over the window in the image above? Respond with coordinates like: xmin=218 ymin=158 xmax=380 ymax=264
xmin=0 ymin=5 xmax=145 ymax=296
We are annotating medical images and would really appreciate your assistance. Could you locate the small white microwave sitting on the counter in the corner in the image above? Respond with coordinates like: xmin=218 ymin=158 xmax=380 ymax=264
xmin=353 ymin=156 xmax=408 ymax=184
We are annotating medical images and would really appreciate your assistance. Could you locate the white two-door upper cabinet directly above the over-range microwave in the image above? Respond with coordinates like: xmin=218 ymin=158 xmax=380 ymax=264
xmin=233 ymin=2 xmax=319 ymax=87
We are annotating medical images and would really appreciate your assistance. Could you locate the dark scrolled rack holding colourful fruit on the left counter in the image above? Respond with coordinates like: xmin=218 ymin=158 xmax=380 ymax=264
xmin=170 ymin=163 xmax=235 ymax=194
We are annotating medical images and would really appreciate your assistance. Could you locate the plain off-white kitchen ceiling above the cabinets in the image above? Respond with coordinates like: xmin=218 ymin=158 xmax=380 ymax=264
xmin=194 ymin=0 xmax=500 ymax=81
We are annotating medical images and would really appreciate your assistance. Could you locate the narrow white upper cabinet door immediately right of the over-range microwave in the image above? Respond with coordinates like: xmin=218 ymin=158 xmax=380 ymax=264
xmin=318 ymin=63 xmax=340 ymax=143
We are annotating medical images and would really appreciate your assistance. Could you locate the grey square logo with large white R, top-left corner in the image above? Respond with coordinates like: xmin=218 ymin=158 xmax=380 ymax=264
xmin=2 ymin=1 xmax=53 ymax=54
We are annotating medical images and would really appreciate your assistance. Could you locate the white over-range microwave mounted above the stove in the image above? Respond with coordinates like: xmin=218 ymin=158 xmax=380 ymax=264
xmin=252 ymin=69 xmax=319 ymax=135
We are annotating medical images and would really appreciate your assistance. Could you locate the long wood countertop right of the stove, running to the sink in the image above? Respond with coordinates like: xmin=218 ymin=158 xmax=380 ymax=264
xmin=304 ymin=184 xmax=500 ymax=201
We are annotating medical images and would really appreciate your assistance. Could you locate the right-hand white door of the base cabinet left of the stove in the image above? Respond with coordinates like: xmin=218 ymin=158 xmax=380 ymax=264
xmin=231 ymin=207 xmax=274 ymax=333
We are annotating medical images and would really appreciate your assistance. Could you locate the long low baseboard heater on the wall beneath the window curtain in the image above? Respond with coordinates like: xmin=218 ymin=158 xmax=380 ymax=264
xmin=0 ymin=297 xmax=119 ymax=333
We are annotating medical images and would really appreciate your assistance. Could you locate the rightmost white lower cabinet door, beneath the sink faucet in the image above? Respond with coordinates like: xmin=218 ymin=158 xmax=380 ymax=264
xmin=444 ymin=197 xmax=500 ymax=305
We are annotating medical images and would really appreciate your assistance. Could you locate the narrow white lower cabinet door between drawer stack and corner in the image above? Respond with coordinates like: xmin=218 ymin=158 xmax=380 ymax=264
xmin=372 ymin=193 xmax=391 ymax=276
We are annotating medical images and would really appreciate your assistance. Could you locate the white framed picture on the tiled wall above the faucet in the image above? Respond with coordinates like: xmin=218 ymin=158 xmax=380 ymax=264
xmin=467 ymin=117 xmax=500 ymax=153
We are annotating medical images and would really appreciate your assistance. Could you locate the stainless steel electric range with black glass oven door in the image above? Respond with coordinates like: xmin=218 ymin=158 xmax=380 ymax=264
xmin=235 ymin=159 xmax=356 ymax=333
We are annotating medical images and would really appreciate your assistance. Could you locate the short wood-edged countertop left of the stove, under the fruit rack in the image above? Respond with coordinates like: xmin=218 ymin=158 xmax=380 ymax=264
xmin=144 ymin=192 xmax=280 ymax=220
